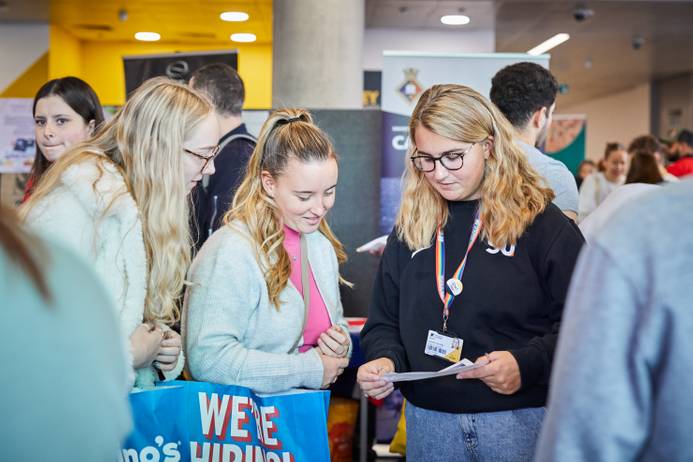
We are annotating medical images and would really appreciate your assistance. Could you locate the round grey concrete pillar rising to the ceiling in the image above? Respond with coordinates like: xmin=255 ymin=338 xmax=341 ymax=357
xmin=272 ymin=0 xmax=365 ymax=109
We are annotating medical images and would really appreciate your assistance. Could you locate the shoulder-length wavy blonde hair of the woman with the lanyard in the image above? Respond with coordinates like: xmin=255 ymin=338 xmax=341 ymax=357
xmin=395 ymin=84 xmax=554 ymax=250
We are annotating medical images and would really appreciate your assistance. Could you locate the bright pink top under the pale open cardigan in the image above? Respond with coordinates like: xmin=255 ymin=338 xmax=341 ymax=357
xmin=284 ymin=226 xmax=332 ymax=353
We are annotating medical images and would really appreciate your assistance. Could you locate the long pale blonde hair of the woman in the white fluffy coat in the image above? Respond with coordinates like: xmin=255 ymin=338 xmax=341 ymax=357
xmin=21 ymin=77 xmax=212 ymax=325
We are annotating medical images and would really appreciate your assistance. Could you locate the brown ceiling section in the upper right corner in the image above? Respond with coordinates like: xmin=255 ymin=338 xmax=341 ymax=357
xmin=496 ymin=0 xmax=693 ymax=105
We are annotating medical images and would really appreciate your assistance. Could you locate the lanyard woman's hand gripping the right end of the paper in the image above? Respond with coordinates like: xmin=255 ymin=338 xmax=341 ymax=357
xmin=457 ymin=351 xmax=522 ymax=395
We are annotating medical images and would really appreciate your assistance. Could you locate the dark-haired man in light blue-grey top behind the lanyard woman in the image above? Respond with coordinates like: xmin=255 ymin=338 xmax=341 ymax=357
xmin=491 ymin=62 xmax=578 ymax=221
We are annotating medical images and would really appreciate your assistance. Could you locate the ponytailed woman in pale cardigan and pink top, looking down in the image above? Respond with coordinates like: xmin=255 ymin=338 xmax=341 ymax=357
xmin=183 ymin=109 xmax=351 ymax=393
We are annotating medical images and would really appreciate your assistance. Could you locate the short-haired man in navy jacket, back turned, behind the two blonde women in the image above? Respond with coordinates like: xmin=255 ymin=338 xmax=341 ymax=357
xmin=190 ymin=63 xmax=256 ymax=249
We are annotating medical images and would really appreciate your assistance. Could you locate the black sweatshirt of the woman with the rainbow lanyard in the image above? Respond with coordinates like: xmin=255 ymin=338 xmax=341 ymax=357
xmin=361 ymin=201 xmax=584 ymax=413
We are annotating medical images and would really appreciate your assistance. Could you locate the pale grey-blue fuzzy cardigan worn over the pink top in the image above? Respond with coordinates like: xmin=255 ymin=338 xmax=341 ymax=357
xmin=182 ymin=221 xmax=348 ymax=393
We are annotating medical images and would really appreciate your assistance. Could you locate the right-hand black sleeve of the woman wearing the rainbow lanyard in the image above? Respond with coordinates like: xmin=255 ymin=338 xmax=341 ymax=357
xmin=510 ymin=219 xmax=584 ymax=389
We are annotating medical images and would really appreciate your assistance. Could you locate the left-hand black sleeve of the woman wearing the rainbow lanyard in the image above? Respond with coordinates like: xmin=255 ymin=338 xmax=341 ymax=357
xmin=361 ymin=235 xmax=410 ymax=372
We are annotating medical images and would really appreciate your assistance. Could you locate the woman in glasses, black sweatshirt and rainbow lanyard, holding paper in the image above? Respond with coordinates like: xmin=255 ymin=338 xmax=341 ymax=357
xmin=358 ymin=85 xmax=583 ymax=461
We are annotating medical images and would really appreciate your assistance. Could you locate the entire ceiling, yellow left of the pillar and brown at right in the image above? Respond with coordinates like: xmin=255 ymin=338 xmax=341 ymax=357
xmin=0 ymin=0 xmax=693 ymax=106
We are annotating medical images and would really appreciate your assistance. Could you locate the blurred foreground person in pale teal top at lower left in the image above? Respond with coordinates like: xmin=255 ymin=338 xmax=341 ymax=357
xmin=0 ymin=206 xmax=131 ymax=462
